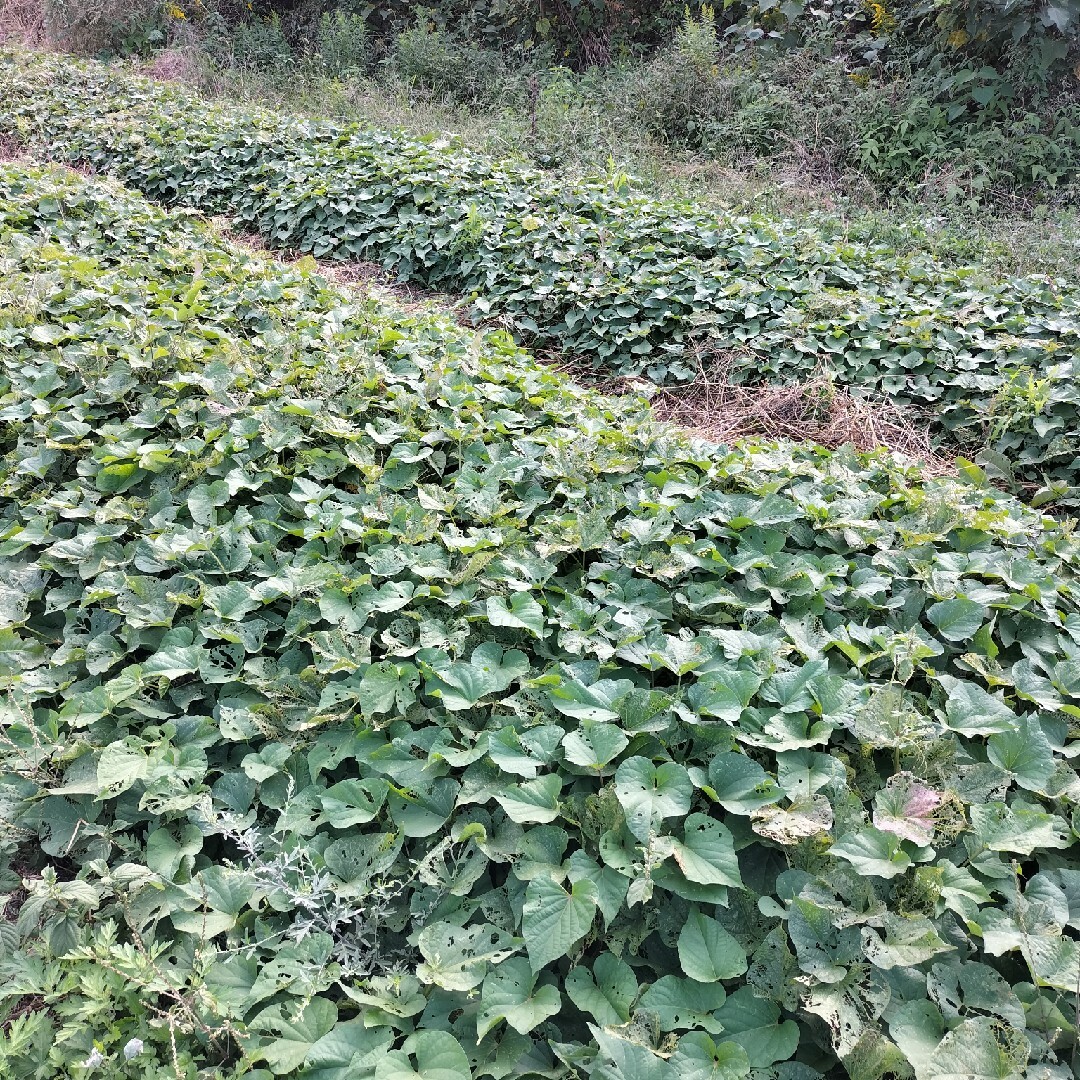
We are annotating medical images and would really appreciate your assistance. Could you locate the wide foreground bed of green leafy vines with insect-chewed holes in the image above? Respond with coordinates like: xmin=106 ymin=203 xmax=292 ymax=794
xmin=0 ymin=162 xmax=1080 ymax=1080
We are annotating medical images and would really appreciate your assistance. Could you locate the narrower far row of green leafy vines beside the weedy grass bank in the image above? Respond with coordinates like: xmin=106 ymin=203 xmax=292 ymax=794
xmin=0 ymin=48 xmax=1080 ymax=499
